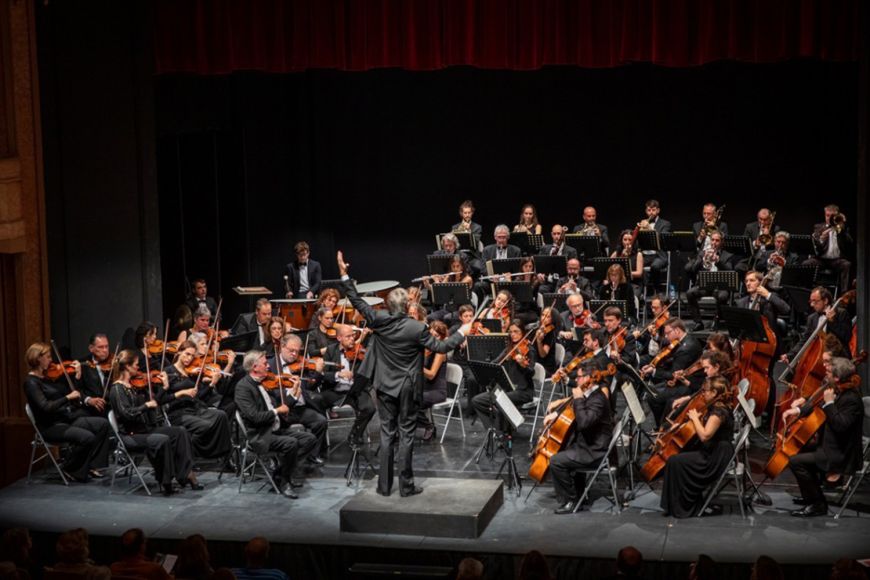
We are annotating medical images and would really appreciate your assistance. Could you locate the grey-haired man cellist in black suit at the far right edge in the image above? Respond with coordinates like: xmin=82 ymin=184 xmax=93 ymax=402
xmin=782 ymin=357 xmax=864 ymax=517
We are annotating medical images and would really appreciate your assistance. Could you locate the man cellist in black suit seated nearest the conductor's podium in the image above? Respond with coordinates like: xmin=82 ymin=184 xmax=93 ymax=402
xmin=544 ymin=361 xmax=613 ymax=514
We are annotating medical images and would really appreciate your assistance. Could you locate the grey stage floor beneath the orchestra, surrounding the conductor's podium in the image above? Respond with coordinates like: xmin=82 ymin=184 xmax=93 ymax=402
xmin=0 ymin=412 xmax=870 ymax=564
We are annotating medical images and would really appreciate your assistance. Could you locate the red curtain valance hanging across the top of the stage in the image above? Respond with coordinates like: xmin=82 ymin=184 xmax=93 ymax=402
xmin=154 ymin=0 xmax=863 ymax=75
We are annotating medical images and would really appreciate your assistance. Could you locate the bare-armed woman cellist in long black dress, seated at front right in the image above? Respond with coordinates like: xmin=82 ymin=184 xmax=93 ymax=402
xmin=661 ymin=376 xmax=734 ymax=518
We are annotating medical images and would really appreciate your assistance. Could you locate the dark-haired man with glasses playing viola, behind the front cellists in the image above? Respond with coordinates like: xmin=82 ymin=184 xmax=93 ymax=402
xmin=640 ymin=317 xmax=704 ymax=425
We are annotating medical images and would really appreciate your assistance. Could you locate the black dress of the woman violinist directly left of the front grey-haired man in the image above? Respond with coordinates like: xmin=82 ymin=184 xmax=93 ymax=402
xmin=166 ymin=365 xmax=231 ymax=458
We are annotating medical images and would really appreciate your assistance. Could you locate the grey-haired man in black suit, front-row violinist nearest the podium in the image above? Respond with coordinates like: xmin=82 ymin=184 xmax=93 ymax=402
xmin=235 ymin=350 xmax=317 ymax=499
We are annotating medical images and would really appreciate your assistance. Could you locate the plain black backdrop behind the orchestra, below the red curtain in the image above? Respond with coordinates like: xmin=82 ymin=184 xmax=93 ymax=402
xmin=155 ymin=61 xmax=858 ymax=322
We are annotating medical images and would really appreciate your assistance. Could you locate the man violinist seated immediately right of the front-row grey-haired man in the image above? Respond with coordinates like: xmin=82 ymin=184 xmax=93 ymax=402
xmin=270 ymin=334 xmax=328 ymax=465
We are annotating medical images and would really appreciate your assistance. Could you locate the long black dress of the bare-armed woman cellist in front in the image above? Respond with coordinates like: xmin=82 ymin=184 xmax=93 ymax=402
xmin=661 ymin=404 xmax=734 ymax=518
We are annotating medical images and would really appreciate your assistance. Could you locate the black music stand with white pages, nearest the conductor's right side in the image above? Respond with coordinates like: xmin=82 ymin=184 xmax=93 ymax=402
xmin=468 ymin=360 xmax=523 ymax=495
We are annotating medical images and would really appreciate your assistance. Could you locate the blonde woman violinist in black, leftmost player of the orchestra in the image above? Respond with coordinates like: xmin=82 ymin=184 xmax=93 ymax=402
xmin=24 ymin=342 xmax=109 ymax=483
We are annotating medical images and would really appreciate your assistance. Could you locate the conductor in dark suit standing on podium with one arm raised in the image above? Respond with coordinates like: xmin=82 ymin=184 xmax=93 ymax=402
xmin=336 ymin=252 xmax=469 ymax=497
